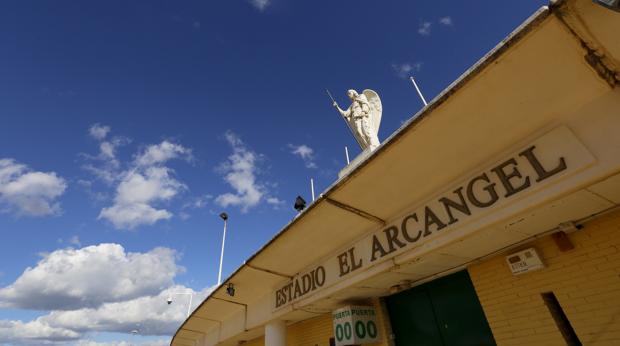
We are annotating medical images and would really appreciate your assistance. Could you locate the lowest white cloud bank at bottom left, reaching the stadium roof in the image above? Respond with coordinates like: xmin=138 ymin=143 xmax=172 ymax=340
xmin=0 ymin=285 xmax=215 ymax=346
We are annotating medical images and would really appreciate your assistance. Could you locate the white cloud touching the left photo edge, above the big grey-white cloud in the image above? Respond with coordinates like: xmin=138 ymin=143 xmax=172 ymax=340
xmin=0 ymin=159 xmax=67 ymax=216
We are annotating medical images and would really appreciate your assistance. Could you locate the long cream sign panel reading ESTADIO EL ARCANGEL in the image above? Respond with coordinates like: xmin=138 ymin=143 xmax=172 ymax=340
xmin=274 ymin=126 xmax=596 ymax=309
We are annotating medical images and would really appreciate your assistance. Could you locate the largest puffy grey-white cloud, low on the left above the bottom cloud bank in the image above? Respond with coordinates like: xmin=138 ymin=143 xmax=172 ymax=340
xmin=0 ymin=244 xmax=183 ymax=310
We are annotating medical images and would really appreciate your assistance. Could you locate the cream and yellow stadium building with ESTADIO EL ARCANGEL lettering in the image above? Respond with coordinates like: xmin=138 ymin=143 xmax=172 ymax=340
xmin=171 ymin=0 xmax=620 ymax=346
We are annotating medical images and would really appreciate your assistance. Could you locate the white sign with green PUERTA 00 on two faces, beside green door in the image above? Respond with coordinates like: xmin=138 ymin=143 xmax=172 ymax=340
xmin=332 ymin=306 xmax=381 ymax=346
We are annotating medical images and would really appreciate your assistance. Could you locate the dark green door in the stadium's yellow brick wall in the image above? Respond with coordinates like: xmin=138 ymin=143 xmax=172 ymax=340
xmin=386 ymin=271 xmax=495 ymax=346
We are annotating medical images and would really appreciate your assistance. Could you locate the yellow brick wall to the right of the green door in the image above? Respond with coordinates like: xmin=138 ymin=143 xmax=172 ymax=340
xmin=468 ymin=212 xmax=620 ymax=346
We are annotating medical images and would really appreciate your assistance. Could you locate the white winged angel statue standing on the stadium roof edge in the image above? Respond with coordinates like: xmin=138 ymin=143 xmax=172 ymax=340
xmin=328 ymin=89 xmax=383 ymax=151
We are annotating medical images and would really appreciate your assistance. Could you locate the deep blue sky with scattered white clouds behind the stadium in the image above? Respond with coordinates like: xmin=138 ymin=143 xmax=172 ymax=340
xmin=0 ymin=0 xmax=546 ymax=345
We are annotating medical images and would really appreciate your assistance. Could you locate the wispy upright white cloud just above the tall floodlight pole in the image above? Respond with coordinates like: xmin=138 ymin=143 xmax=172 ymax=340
xmin=215 ymin=131 xmax=266 ymax=212
